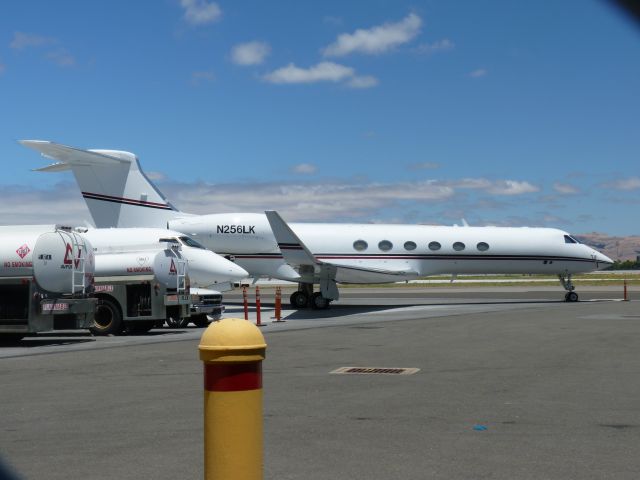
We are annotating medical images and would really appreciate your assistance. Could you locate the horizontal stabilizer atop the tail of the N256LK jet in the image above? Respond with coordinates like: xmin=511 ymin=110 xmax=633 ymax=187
xmin=20 ymin=140 xmax=129 ymax=172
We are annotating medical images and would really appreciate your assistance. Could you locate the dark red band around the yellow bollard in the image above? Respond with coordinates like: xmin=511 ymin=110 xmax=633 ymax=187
xmin=204 ymin=362 xmax=262 ymax=392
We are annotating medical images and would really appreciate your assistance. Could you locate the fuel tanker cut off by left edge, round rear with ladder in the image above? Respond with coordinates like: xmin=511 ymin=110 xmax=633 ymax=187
xmin=0 ymin=225 xmax=96 ymax=342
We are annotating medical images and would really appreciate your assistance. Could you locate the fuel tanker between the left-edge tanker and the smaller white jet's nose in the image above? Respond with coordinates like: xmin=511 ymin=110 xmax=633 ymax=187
xmin=90 ymin=240 xmax=192 ymax=335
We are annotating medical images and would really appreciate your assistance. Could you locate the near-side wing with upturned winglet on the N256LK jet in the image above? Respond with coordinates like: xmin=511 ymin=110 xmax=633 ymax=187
xmin=264 ymin=210 xmax=418 ymax=282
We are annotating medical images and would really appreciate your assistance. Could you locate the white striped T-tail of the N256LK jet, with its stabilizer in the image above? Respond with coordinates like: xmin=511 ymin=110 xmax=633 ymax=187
xmin=20 ymin=140 xmax=183 ymax=228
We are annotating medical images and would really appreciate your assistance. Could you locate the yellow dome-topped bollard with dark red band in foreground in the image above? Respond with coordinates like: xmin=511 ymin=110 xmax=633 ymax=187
xmin=198 ymin=318 xmax=267 ymax=480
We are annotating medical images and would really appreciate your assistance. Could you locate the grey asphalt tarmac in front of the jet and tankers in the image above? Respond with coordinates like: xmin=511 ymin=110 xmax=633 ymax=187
xmin=0 ymin=287 xmax=640 ymax=480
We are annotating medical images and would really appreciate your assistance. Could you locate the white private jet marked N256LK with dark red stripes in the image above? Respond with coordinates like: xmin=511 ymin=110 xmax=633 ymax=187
xmin=21 ymin=140 xmax=613 ymax=308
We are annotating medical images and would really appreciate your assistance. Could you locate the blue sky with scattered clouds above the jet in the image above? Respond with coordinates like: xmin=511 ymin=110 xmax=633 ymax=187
xmin=0 ymin=0 xmax=640 ymax=235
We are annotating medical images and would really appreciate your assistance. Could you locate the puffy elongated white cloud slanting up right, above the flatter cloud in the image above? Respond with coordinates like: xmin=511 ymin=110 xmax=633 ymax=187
xmin=323 ymin=13 xmax=422 ymax=57
